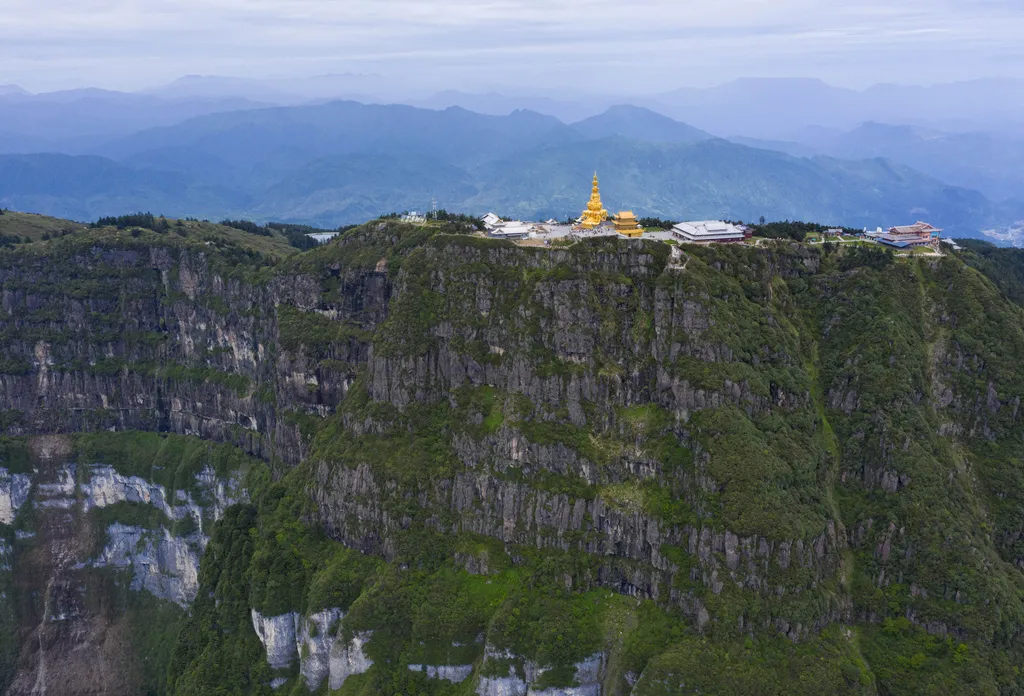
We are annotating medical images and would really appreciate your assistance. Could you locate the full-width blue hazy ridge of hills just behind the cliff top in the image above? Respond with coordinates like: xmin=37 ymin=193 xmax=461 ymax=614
xmin=0 ymin=96 xmax=1024 ymax=237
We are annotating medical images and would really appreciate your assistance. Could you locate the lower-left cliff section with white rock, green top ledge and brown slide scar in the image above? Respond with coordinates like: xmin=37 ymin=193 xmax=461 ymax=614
xmin=0 ymin=435 xmax=261 ymax=694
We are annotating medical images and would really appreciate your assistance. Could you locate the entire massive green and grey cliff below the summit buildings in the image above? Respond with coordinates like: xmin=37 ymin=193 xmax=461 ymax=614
xmin=0 ymin=222 xmax=1024 ymax=696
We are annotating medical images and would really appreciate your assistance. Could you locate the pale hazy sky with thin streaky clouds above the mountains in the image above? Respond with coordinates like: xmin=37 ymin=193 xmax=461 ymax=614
xmin=0 ymin=0 xmax=1024 ymax=94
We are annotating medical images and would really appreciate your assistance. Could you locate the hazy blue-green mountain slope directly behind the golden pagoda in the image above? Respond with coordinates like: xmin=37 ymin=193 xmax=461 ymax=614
xmin=468 ymin=138 xmax=995 ymax=235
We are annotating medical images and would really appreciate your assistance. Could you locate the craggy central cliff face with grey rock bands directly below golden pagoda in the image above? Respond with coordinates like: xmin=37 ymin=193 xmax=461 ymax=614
xmin=311 ymin=237 xmax=845 ymax=635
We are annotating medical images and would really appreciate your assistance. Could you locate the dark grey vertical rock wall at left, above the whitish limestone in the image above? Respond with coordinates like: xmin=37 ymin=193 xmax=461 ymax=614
xmin=0 ymin=241 xmax=368 ymax=462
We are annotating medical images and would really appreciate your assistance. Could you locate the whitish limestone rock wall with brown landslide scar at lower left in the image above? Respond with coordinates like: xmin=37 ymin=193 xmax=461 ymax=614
xmin=0 ymin=436 xmax=247 ymax=696
